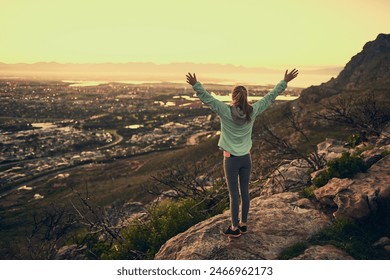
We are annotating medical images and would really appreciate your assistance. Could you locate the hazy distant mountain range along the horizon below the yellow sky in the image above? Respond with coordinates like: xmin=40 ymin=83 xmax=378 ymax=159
xmin=0 ymin=62 xmax=342 ymax=86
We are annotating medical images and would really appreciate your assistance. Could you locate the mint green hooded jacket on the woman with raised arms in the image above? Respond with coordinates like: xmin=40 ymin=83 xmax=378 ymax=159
xmin=193 ymin=80 xmax=287 ymax=156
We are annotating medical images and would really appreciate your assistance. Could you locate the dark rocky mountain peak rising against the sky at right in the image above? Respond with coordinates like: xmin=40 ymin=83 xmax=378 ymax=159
xmin=290 ymin=34 xmax=390 ymax=128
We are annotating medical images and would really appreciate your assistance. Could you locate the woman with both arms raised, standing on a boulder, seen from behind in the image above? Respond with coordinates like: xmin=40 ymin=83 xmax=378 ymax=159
xmin=186 ymin=69 xmax=298 ymax=237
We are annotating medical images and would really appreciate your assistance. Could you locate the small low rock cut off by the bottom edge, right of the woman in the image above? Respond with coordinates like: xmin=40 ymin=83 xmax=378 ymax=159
xmin=292 ymin=245 xmax=354 ymax=260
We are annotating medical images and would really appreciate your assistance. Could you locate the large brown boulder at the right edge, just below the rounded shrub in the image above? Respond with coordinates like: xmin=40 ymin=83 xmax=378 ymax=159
xmin=314 ymin=156 xmax=390 ymax=219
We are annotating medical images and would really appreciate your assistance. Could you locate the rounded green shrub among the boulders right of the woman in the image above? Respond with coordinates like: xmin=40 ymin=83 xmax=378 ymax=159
xmin=313 ymin=152 xmax=367 ymax=187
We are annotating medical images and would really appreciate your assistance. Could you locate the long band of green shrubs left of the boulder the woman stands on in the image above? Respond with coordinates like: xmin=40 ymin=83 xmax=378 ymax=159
xmin=74 ymin=184 xmax=228 ymax=259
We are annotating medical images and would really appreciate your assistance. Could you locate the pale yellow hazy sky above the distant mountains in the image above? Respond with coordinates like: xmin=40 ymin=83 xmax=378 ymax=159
xmin=0 ymin=0 xmax=390 ymax=68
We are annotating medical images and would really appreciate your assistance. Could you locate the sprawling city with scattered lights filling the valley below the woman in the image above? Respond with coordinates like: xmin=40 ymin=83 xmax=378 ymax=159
xmin=0 ymin=79 xmax=300 ymax=243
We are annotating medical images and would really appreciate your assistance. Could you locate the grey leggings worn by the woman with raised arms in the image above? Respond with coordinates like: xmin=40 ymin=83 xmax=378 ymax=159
xmin=223 ymin=154 xmax=252 ymax=227
